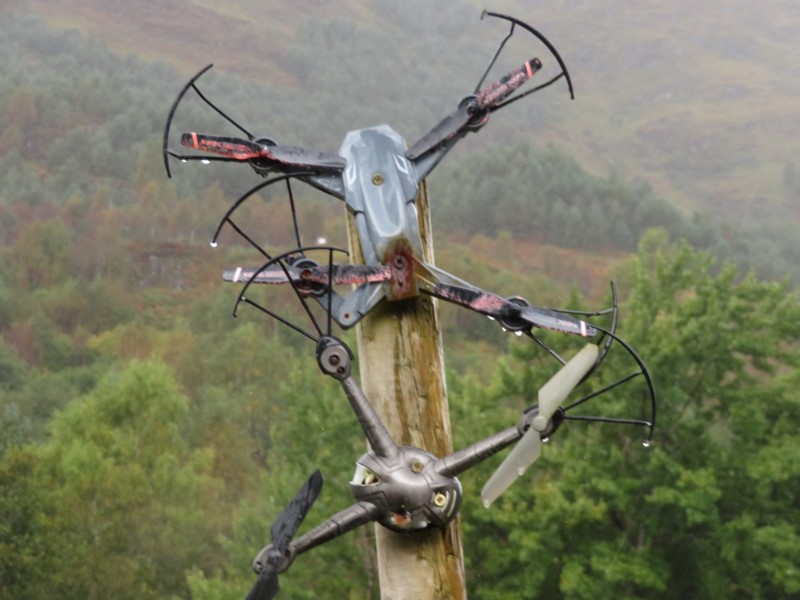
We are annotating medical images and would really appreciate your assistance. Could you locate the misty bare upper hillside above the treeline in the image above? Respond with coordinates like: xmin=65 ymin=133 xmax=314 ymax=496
xmin=18 ymin=0 xmax=800 ymax=226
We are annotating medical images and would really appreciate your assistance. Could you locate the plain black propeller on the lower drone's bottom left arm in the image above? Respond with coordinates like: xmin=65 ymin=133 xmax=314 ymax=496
xmin=246 ymin=469 xmax=323 ymax=600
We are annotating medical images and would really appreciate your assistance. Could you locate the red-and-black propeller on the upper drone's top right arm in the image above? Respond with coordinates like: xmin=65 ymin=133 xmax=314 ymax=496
xmin=406 ymin=58 xmax=542 ymax=160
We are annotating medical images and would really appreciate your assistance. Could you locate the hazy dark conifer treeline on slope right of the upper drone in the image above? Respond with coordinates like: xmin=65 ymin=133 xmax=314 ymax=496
xmin=433 ymin=143 xmax=800 ymax=283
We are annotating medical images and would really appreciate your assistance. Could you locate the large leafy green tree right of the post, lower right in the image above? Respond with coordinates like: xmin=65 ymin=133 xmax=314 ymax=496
xmin=462 ymin=232 xmax=800 ymax=598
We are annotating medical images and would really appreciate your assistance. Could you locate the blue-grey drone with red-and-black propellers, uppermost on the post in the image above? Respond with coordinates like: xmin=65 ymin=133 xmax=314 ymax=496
xmin=163 ymin=11 xmax=649 ymax=370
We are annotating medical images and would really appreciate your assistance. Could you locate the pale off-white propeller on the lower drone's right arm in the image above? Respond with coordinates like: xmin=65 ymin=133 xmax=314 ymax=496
xmin=481 ymin=344 xmax=599 ymax=508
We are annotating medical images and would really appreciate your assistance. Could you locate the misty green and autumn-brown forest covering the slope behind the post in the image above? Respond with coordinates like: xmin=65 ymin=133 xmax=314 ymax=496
xmin=0 ymin=5 xmax=800 ymax=600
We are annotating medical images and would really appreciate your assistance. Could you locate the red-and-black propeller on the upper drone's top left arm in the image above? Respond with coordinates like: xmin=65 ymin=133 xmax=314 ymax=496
xmin=181 ymin=132 xmax=346 ymax=172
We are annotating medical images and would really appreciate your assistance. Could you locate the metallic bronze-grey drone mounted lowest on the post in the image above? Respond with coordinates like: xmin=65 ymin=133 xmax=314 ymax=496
xmin=230 ymin=248 xmax=655 ymax=600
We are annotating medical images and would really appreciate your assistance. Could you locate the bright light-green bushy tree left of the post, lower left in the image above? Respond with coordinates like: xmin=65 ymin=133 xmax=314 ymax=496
xmin=33 ymin=362 xmax=228 ymax=599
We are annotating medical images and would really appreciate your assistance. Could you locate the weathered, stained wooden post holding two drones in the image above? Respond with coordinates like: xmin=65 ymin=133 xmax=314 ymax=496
xmin=348 ymin=182 xmax=467 ymax=600
